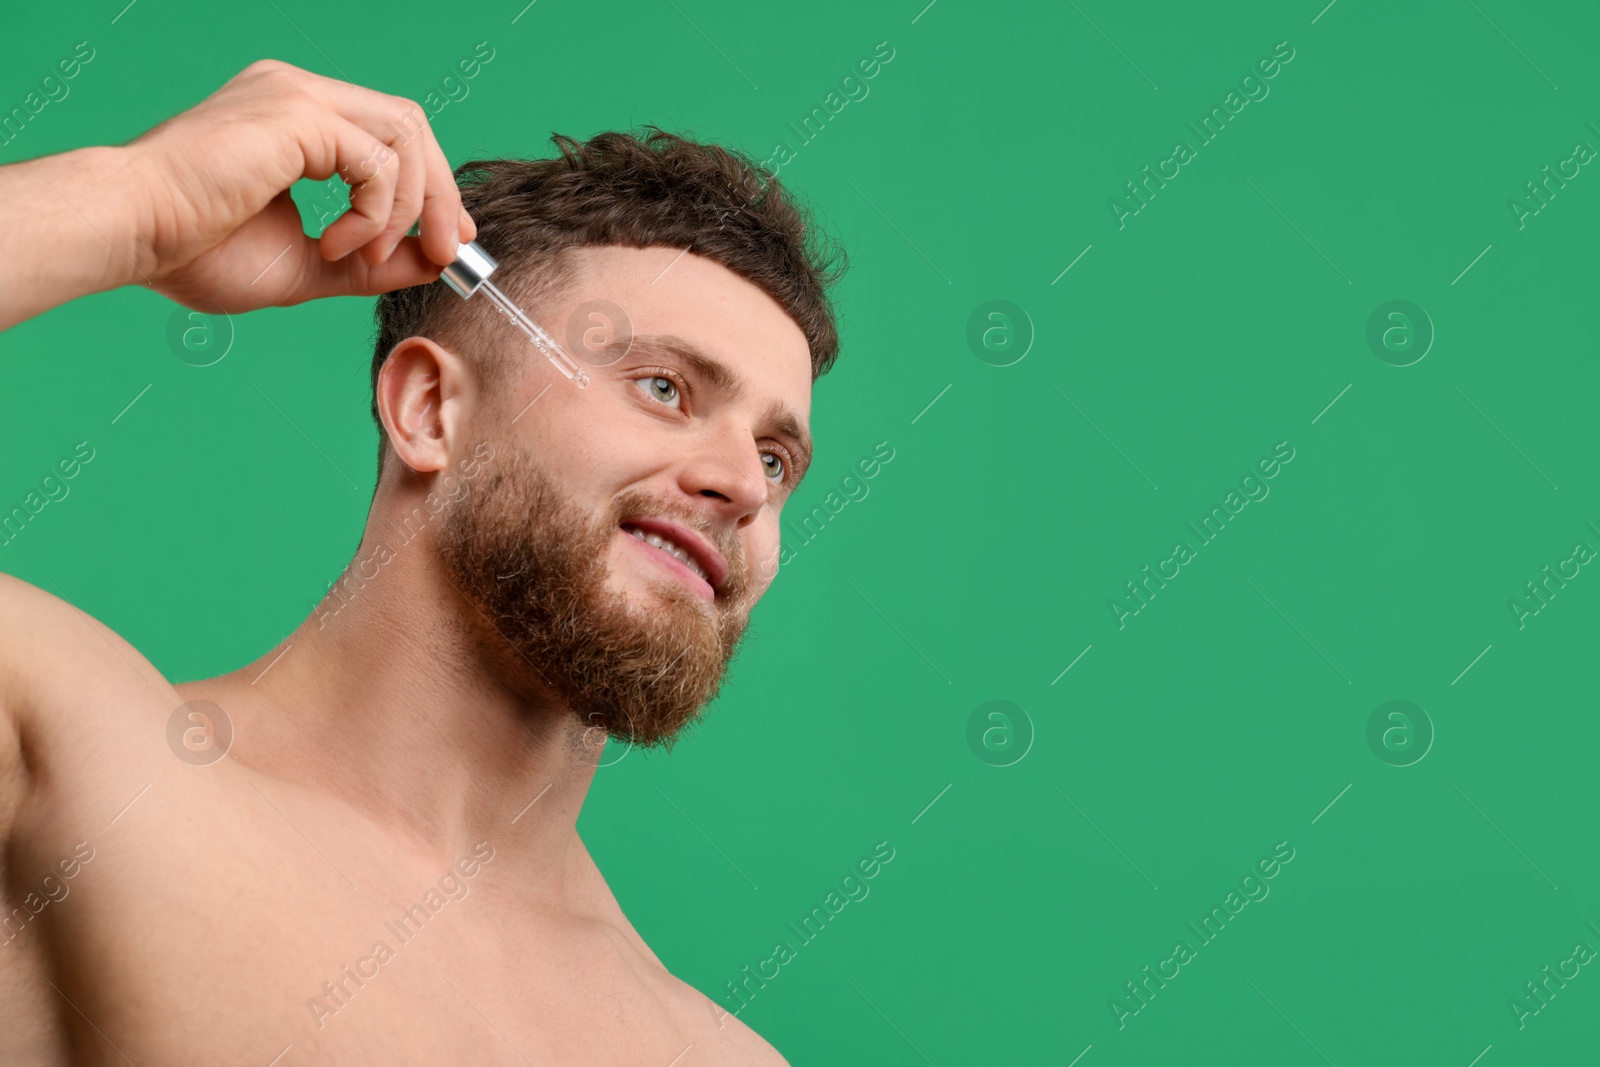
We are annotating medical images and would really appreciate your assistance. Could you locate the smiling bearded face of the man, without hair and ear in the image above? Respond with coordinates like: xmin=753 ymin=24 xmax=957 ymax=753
xmin=440 ymin=246 xmax=811 ymax=744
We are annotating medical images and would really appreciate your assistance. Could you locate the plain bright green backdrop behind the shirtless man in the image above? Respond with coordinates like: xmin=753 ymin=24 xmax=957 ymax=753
xmin=0 ymin=0 xmax=1600 ymax=1067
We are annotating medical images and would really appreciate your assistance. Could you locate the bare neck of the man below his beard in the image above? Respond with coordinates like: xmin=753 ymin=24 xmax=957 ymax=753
xmin=182 ymin=524 xmax=605 ymax=896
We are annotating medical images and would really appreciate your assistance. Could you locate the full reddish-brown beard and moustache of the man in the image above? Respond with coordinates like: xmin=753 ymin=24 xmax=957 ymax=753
xmin=438 ymin=448 xmax=749 ymax=750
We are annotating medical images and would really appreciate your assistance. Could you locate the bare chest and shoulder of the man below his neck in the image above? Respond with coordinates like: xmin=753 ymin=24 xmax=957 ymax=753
xmin=0 ymin=776 xmax=782 ymax=1067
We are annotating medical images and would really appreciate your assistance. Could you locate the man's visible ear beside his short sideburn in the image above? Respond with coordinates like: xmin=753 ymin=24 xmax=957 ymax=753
xmin=378 ymin=338 xmax=475 ymax=474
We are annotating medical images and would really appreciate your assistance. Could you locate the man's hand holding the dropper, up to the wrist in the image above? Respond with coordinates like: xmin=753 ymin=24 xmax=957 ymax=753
xmin=120 ymin=59 xmax=477 ymax=312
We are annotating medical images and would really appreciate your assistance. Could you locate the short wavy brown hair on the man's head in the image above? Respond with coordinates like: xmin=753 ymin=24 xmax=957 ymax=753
xmin=371 ymin=126 xmax=846 ymax=475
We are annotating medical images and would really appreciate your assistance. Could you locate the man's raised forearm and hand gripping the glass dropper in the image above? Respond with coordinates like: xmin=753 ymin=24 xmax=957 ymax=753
xmin=0 ymin=59 xmax=477 ymax=330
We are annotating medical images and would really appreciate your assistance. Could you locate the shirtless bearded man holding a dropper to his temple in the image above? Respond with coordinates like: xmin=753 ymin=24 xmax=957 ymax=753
xmin=0 ymin=61 xmax=837 ymax=1067
